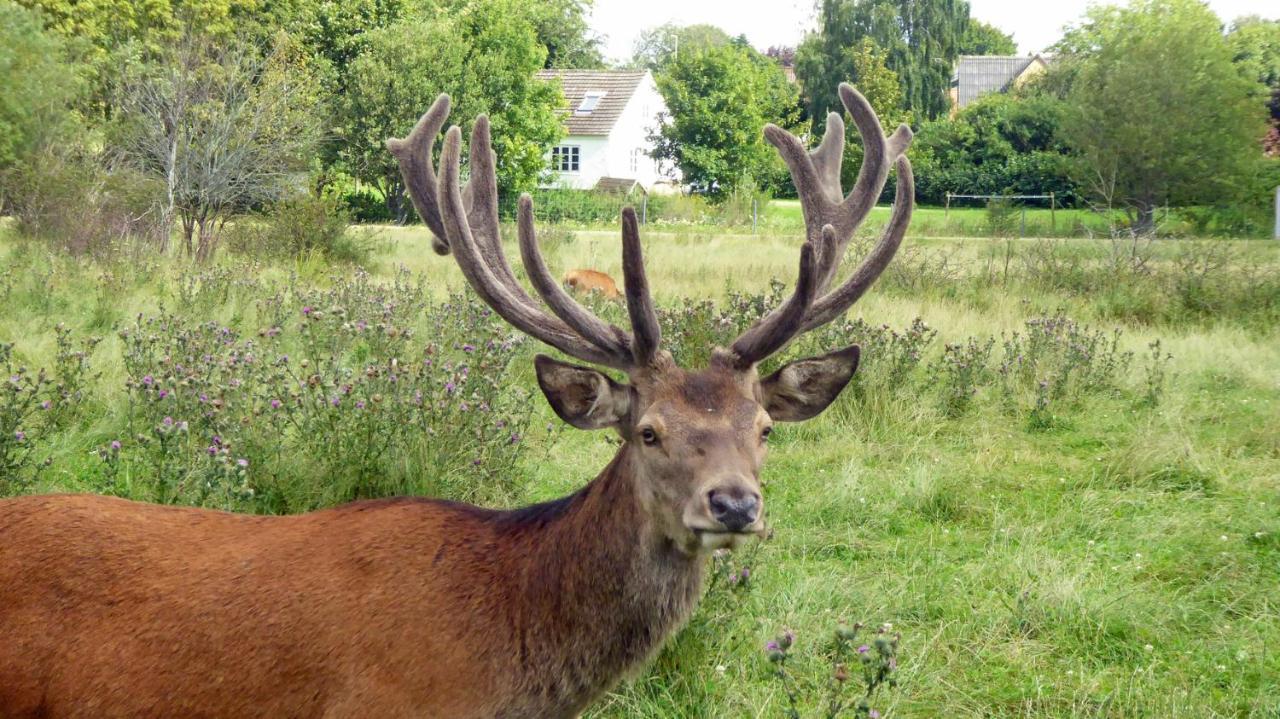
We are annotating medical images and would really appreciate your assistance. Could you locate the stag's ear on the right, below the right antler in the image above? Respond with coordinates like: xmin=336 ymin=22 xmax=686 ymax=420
xmin=760 ymin=344 xmax=860 ymax=422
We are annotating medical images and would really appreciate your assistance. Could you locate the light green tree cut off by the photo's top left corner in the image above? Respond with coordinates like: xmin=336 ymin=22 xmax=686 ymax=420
xmin=0 ymin=0 xmax=84 ymax=173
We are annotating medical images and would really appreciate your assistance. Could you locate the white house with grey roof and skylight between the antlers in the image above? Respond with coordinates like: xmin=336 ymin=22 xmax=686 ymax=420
xmin=538 ymin=70 xmax=680 ymax=191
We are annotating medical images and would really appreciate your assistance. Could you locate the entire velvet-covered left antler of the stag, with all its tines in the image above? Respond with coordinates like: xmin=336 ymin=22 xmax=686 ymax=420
xmin=387 ymin=95 xmax=660 ymax=371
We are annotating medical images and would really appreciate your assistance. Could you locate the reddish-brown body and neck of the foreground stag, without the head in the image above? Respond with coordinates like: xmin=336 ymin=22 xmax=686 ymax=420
xmin=0 ymin=448 xmax=701 ymax=718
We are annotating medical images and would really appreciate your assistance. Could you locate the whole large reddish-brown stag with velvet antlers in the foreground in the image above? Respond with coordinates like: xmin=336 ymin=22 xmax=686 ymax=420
xmin=0 ymin=84 xmax=913 ymax=719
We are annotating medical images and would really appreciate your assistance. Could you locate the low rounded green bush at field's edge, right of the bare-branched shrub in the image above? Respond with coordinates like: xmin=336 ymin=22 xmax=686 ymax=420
xmin=227 ymin=194 xmax=371 ymax=264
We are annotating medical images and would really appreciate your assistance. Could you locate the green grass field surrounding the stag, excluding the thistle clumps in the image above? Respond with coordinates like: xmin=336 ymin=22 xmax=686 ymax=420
xmin=0 ymin=221 xmax=1280 ymax=718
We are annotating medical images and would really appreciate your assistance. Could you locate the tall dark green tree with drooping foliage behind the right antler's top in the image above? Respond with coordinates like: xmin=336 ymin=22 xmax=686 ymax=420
xmin=796 ymin=0 xmax=969 ymax=119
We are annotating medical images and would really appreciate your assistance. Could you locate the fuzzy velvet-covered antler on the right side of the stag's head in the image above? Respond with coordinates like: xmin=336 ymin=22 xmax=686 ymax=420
xmin=731 ymin=83 xmax=915 ymax=367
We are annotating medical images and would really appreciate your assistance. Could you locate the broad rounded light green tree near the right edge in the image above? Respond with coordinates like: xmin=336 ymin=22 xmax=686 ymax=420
xmin=1062 ymin=0 xmax=1262 ymax=232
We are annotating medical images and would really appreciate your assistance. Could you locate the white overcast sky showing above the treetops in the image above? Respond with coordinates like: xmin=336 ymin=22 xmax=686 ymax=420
xmin=591 ymin=0 xmax=1280 ymax=60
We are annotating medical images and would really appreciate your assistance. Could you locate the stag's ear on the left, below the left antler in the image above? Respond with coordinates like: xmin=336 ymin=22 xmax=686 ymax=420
xmin=534 ymin=354 xmax=631 ymax=430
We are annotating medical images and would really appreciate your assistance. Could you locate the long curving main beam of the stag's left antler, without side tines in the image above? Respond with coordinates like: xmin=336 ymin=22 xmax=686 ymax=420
xmin=436 ymin=125 xmax=631 ymax=370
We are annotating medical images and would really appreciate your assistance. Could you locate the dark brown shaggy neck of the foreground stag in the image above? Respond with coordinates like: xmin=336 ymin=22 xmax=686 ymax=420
xmin=499 ymin=444 xmax=704 ymax=707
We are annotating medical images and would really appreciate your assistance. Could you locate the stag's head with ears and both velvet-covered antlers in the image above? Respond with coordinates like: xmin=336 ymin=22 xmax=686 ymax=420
xmin=388 ymin=84 xmax=914 ymax=555
